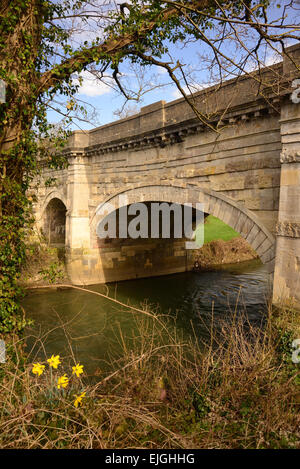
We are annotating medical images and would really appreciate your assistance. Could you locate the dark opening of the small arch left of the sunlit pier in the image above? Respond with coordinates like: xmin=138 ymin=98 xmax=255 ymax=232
xmin=43 ymin=198 xmax=67 ymax=245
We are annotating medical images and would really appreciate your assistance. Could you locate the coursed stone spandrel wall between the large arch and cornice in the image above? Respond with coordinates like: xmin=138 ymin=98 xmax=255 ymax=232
xmin=89 ymin=113 xmax=281 ymax=232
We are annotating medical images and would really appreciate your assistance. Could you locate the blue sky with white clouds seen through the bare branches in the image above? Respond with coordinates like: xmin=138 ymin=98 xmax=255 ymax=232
xmin=48 ymin=0 xmax=300 ymax=130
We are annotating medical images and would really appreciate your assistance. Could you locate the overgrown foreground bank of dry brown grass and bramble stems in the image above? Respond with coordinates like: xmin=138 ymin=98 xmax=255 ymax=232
xmin=0 ymin=302 xmax=300 ymax=448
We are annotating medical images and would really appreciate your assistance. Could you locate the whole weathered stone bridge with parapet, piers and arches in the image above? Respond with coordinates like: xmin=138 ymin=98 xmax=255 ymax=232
xmin=35 ymin=46 xmax=300 ymax=302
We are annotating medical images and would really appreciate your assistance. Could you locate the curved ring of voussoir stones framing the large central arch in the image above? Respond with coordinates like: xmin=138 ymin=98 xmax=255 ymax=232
xmin=90 ymin=184 xmax=275 ymax=272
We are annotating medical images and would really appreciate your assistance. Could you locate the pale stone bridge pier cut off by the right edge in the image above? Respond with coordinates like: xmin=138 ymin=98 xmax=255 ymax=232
xmin=273 ymin=100 xmax=300 ymax=303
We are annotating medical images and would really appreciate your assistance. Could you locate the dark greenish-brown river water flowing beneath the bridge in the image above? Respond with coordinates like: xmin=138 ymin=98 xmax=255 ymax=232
xmin=23 ymin=260 xmax=269 ymax=375
